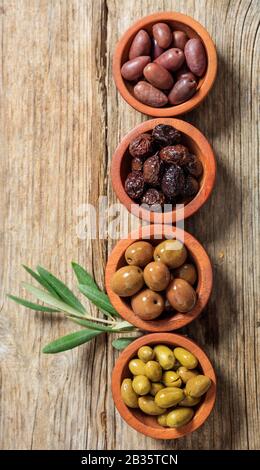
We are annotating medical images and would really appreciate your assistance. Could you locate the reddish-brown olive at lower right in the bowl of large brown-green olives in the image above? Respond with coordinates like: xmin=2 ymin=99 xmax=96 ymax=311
xmin=166 ymin=279 xmax=197 ymax=313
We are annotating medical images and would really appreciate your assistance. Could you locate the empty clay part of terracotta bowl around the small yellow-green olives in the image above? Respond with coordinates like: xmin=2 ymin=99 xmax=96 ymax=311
xmin=112 ymin=333 xmax=216 ymax=439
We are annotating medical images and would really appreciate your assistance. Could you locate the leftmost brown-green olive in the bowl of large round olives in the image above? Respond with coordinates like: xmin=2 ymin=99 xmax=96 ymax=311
xmin=110 ymin=266 xmax=144 ymax=297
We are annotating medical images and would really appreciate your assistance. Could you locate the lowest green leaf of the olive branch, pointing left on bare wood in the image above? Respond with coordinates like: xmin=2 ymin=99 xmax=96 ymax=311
xmin=42 ymin=330 xmax=102 ymax=354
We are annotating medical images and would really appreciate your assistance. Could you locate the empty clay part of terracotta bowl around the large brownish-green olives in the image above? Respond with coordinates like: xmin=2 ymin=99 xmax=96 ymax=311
xmin=105 ymin=225 xmax=213 ymax=332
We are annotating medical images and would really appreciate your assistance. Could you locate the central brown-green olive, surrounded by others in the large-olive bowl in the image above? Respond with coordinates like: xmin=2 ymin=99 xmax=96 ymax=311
xmin=144 ymin=261 xmax=171 ymax=292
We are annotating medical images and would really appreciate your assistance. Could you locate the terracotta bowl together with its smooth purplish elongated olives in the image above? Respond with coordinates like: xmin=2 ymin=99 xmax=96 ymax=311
xmin=113 ymin=12 xmax=217 ymax=117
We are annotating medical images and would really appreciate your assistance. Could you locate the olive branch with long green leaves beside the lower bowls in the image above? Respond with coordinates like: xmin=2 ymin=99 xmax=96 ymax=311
xmin=7 ymin=262 xmax=138 ymax=354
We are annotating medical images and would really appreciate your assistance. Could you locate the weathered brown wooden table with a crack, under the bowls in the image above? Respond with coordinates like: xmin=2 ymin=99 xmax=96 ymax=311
xmin=0 ymin=0 xmax=260 ymax=450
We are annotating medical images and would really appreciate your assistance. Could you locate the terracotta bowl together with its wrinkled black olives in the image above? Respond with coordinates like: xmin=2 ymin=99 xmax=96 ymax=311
xmin=111 ymin=118 xmax=216 ymax=224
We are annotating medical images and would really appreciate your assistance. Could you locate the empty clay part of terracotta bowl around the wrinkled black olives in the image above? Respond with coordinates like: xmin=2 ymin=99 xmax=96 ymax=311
xmin=111 ymin=118 xmax=216 ymax=224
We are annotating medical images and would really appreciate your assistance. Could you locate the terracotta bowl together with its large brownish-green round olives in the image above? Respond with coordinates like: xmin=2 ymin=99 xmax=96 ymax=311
xmin=105 ymin=225 xmax=213 ymax=332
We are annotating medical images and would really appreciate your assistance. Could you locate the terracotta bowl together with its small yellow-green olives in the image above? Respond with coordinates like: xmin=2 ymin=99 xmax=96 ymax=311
xmin=112 ymin=333 xmax=216 ymax=439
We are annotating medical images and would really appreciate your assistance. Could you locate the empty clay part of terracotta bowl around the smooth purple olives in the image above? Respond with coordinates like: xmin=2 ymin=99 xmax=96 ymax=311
xmin=113 ymin=12 xmax=217 ymax=117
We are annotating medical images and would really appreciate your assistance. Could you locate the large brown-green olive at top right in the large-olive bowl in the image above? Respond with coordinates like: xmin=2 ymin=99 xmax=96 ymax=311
xmin=154 ymin=240 xmax=187 ymax=268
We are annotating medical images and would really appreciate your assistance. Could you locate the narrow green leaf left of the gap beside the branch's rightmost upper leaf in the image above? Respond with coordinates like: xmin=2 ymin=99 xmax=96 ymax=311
xmin=37 ymin=266 xmax=86 ymax=315
